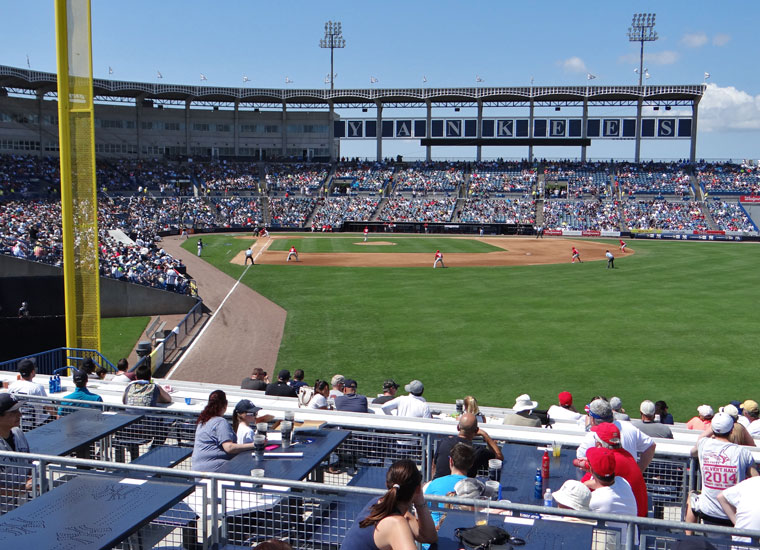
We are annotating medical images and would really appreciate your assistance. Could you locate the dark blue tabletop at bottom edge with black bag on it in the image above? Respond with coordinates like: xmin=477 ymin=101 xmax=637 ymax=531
xmin=430 ymin=510 xmax=594 ymax=550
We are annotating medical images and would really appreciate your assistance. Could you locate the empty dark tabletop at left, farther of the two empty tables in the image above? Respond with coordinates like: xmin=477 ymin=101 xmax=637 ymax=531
xmin=25 ymin=409 xmax=143 ymax=456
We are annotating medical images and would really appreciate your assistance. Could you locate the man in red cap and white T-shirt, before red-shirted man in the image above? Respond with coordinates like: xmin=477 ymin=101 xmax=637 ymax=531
xmin=586 ymin=447 xmax=636 ymax=541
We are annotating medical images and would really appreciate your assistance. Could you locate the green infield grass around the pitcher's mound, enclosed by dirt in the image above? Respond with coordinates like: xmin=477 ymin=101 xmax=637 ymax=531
xmin=269 ymin=234 xmax=504 ymax=254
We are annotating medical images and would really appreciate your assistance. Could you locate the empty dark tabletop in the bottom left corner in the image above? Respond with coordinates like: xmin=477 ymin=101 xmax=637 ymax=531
xmin=0 ymin=475 xmax=194 ymax=550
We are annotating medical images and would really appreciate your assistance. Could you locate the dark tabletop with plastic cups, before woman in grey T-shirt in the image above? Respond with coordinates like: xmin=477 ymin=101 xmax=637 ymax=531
xmin=220 ymin=430 xmax=351 ymax=481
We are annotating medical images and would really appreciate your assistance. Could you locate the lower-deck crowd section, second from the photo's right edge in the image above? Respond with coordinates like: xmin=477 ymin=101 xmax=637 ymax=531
xmin=620 ymin=199 xmax=709 ymax=231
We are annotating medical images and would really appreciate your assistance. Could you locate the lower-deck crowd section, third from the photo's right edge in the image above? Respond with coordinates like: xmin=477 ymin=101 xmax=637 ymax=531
xmin=544 ymin=200 xmax=620 ymax=231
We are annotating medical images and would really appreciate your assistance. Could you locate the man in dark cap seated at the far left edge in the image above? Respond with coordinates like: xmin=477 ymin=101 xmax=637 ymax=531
xmin=0 ymin=393 xmax=32 ymax=514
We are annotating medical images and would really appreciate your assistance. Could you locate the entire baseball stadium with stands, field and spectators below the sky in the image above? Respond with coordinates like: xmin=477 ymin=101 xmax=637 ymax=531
xmin=0 ymin=4 xmax=760 ymax=550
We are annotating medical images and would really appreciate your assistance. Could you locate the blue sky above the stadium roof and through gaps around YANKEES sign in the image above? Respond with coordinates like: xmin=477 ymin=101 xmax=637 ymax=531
xmin=0 ymin=0 xmax=760 ymax=159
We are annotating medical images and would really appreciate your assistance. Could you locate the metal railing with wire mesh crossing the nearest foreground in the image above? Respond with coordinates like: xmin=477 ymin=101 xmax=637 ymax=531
xmin=0 ymin=451 xmax=760 ymax=550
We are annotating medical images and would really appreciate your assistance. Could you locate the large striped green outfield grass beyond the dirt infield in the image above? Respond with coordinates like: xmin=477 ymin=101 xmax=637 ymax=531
xmin=181 ymin=235 xmax=760 ymax=420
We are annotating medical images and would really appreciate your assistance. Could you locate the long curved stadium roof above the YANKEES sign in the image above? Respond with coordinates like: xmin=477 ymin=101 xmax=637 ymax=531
xmin=0 ymin=65 xmax=705 ymax=109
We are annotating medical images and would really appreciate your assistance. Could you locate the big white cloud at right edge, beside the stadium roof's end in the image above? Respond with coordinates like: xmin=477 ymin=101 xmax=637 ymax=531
xmin=698 ymin=84 xmax=760 ymax=132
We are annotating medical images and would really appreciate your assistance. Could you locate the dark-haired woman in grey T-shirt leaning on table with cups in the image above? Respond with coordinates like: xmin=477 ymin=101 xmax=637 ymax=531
xmin=192 ymin=390 xmax=253 ymax=472
